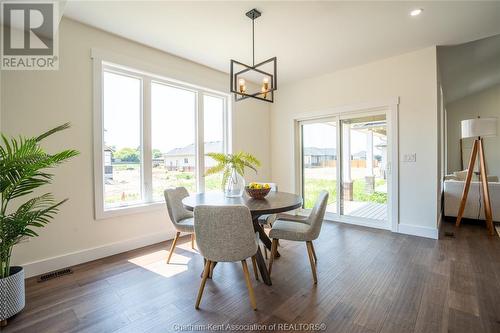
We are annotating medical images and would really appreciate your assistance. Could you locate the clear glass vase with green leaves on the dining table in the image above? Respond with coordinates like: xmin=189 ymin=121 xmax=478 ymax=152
xmin=205 ymin=151 xmax=260 ymax=197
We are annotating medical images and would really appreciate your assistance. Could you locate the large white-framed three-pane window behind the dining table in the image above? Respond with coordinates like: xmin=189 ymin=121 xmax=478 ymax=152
xmin=94 ymin=59 xmax=228 ymax=218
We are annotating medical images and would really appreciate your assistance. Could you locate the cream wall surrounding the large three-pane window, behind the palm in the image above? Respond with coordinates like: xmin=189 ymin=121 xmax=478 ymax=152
xmin=1 ymin=18 xmax=270 ymax=275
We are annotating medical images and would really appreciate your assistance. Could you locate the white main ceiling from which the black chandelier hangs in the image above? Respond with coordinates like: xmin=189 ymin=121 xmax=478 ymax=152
xmin=64 ymin=1 xmax=500 ymax=83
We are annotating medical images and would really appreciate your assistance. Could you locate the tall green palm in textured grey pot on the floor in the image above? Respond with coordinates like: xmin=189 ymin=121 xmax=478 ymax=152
xmin=0 ymin=124 xmax=78 ymax=326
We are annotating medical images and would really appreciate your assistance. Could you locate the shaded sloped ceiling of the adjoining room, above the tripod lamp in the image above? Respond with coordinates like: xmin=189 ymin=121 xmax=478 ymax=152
xmin=438 ymin=35 xmax=500 ymax=103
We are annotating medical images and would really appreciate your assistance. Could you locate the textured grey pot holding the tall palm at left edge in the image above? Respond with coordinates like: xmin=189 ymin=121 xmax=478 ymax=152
xmin=0 ymin=266 xmax=25 ymax=321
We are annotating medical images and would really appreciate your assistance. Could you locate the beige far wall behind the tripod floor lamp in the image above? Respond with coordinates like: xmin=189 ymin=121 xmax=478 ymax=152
xmin=446 ymin=85 xmax=500 ymax=176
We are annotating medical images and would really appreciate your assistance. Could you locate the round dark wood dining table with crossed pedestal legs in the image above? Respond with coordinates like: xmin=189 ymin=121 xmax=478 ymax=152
xmin=182 ymin=191 xmax=302 ymax=285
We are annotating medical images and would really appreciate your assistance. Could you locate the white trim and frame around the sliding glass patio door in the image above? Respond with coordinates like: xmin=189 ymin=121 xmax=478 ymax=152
xmin=293 ymin=97 xmax=399 ymax=232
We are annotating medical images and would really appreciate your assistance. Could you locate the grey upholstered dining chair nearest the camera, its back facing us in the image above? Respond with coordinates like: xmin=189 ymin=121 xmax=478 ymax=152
xmin=194 ymin=205 xmax=258 ymax=310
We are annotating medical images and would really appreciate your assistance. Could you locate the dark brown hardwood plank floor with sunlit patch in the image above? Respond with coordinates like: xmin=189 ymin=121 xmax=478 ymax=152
xmin=3 ymin=222 xmax=500 ymax=333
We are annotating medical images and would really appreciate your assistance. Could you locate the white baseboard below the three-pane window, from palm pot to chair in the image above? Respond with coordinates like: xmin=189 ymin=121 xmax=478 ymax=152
xmin=20 ymin=230 xmax=175 ymax=278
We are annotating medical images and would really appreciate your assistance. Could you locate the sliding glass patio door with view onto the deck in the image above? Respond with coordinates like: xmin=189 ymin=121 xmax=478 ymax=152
xmin=299 ymin=111 xmax=390 ymax=228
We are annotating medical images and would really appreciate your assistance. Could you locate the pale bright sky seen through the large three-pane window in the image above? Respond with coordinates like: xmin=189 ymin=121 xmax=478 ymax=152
xmin=104 ymin=72 xmax=224 ymax=153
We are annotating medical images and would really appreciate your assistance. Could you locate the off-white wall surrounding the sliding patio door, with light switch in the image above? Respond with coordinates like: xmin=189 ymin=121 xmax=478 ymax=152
xmin=271 ymin=47 xmax=439 ymax=236
